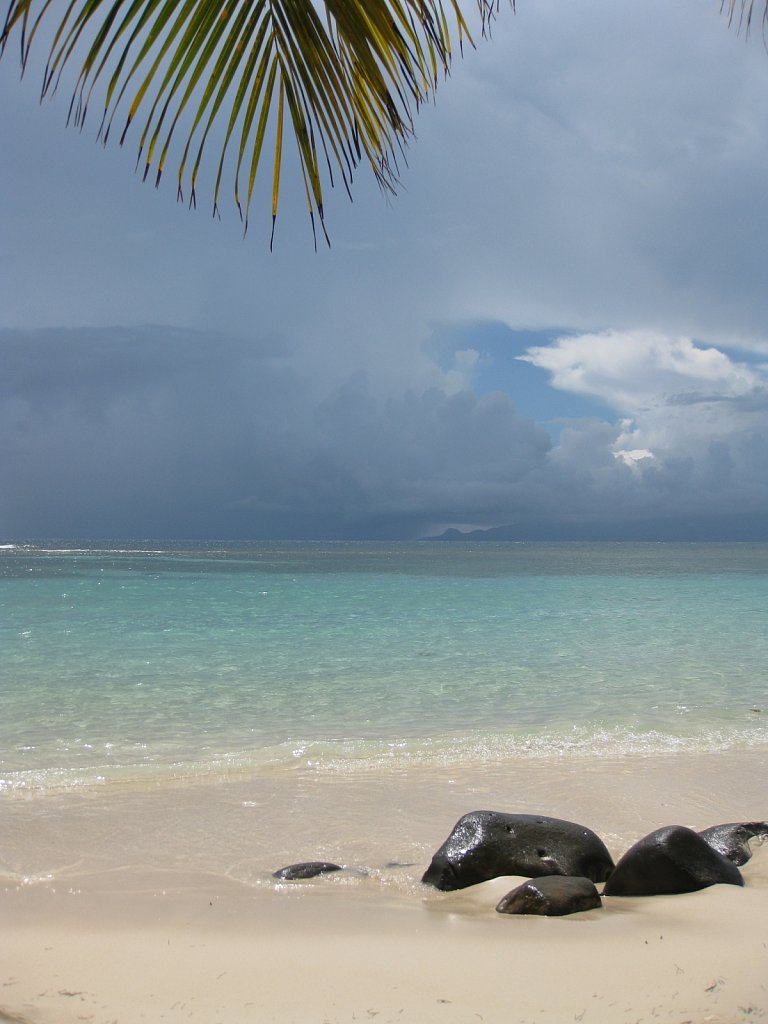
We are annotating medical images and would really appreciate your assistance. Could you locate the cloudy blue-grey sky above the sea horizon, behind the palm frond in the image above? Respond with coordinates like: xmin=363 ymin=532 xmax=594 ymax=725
xmin=0 ymin=0 xmax=768 ymax=543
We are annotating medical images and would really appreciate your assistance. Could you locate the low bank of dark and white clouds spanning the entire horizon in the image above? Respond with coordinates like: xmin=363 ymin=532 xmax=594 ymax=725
xmin=0 ymin=327 xmax=768 ymax=540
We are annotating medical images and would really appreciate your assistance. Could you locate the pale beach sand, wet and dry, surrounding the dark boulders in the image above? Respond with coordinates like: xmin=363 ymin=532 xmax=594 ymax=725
xmin=0 ymin=751 xmax=768 ymax=1024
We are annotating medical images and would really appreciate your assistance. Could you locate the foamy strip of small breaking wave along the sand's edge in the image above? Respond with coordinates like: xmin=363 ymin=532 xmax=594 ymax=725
xmin=6 ymin=706 xmax=768 ymax=799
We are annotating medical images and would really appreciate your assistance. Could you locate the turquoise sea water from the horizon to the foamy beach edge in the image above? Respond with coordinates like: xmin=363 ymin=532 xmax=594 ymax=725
xmin=0 ymin=542 xmax=768 ymax=793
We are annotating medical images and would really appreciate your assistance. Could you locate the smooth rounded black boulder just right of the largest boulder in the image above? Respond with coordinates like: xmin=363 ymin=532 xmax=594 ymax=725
xmin=603 ymin=825 xmax=744 ymax=896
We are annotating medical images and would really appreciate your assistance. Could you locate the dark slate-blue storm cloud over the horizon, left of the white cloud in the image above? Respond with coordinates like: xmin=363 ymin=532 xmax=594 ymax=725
xmin=0 ymin=328 xmax=561 ymax=536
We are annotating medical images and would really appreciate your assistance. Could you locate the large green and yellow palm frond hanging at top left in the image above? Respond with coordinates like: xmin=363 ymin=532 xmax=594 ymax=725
xmin=0 ymin=0 xmax=501 ymax=243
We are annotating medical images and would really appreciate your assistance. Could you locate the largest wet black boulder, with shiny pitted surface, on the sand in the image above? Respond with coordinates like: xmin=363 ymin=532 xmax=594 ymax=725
xmin=422 ymin=811 xmax=613 ymax=891
